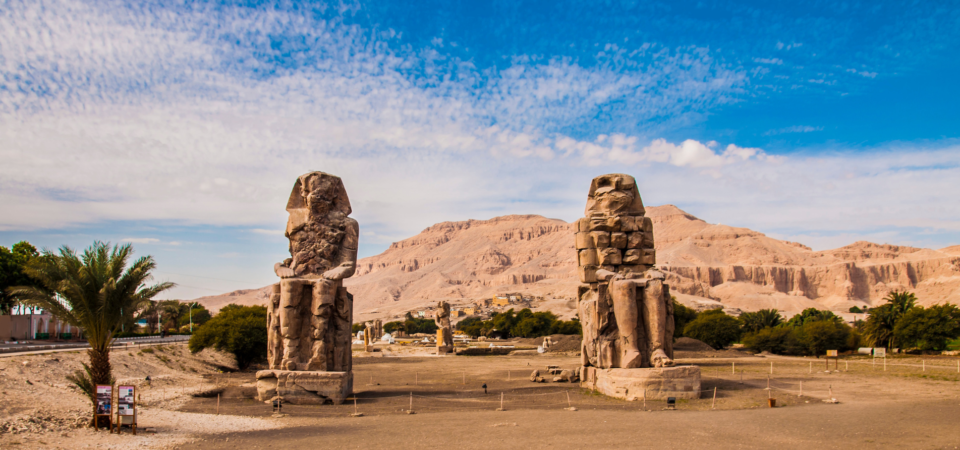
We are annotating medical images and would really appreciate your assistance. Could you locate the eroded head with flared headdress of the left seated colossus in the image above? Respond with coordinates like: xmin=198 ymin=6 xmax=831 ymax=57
xmin=287 ymin=172 xmax=353 ymax=218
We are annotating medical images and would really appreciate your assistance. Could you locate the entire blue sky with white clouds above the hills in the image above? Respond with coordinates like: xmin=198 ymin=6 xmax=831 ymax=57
xmin=0 ymin=0 xmax=960 ymax=298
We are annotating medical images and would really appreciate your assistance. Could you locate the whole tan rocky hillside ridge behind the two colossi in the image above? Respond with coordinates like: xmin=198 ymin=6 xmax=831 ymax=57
xmin=198 ymin=205 xmax=960 ymax=321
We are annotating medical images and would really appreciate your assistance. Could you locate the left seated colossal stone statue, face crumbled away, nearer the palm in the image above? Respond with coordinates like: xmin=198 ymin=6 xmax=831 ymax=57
xmin=257 ymin=172 xmax=359 ymax=403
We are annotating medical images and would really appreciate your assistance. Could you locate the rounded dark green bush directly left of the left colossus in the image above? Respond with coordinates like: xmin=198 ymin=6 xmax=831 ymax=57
xmin=188 ymin=303 xmax=267 ymax=370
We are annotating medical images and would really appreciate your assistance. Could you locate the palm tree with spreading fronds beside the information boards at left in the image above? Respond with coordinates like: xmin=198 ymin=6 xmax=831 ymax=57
xmin=12 ymin=241 xmax=174 ymax=424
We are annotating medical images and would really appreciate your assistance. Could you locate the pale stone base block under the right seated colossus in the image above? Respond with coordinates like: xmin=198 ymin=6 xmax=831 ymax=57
xmin=580 ymin=366 xmax=700 ymax=401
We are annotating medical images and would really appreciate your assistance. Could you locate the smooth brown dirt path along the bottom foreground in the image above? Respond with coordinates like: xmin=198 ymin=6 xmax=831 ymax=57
xmin=174 ymin=400 xmax=960 ymax=449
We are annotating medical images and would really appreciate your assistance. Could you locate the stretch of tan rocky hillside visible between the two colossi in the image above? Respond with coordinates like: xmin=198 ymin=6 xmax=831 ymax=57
xmin=344 ymin=215 xmax=576 ymax=317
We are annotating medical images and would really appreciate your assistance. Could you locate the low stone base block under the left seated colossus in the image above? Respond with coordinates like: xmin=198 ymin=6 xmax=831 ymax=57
xmin=257 ymin=370 xmax=353 ymax=405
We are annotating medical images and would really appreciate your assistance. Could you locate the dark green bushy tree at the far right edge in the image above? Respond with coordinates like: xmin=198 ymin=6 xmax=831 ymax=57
xmin=893 ymin=304 xmax=960 ymax=351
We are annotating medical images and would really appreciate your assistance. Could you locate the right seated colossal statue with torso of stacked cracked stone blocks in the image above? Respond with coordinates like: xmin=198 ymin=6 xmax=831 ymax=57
xmin=576 ymin=174 xmax=699 ymax=397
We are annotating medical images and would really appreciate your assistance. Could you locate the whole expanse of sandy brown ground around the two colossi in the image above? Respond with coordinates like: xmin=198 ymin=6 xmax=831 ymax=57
xmin=0 ymin=347 xmax=960 ymax=449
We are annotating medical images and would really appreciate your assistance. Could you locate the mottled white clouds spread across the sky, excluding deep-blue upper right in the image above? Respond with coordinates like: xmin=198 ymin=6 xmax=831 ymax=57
xmin=0 ymin=0 xmax=960 ymax=300
